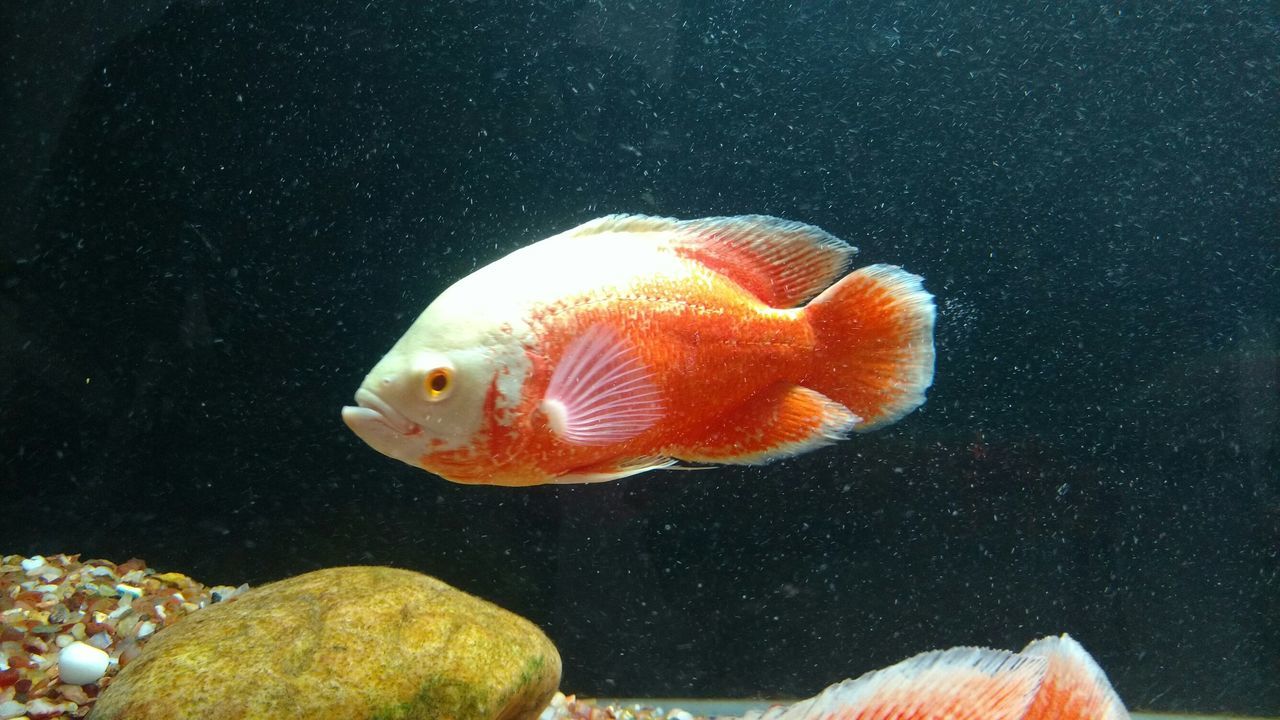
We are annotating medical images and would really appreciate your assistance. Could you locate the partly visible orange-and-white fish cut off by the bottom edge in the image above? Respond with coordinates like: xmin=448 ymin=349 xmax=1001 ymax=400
xmin=742 ymin=635 xmax=1129 ymax=720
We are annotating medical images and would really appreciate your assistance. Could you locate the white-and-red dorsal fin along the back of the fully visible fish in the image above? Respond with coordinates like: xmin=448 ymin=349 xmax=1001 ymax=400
xmin=564 ymin=210 xmax=858 ymax=307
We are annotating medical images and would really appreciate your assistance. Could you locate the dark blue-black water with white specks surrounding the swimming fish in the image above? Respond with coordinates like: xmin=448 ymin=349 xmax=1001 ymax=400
xmin=0 ymin=0 xmax=1280 ymax=714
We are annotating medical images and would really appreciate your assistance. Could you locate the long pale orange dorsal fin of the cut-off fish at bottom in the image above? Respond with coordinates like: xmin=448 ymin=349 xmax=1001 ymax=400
xmin=742 ymin=647 xmax=1044 ymax=720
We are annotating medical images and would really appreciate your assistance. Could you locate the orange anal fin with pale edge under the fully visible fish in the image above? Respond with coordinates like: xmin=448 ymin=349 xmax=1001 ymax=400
xmin=672 ymin=386 xmax=859 ymax=465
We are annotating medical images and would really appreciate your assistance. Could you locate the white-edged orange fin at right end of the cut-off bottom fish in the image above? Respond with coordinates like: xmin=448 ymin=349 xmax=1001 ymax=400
xmin=1023 ymin=635 xmax=1129 ymax=720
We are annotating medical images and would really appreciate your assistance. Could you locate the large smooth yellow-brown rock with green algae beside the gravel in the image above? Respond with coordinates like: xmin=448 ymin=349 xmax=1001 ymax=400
xmin=90 ymin=568 xmax=561 ymax=720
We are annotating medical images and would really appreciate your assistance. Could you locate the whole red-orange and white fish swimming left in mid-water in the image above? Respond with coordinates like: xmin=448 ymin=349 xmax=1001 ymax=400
xmin=342 ymin=215 xmax=934 ymax=486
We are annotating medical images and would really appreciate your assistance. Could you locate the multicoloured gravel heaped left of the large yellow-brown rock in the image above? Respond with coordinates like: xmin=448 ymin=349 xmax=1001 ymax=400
xmin=0 ymin=555 xmax=248 ymax=720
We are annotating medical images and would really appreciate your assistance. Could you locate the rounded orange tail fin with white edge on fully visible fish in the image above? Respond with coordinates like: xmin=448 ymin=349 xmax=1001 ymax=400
xmin=801 ymin=265 xmax=936 ymax=432
